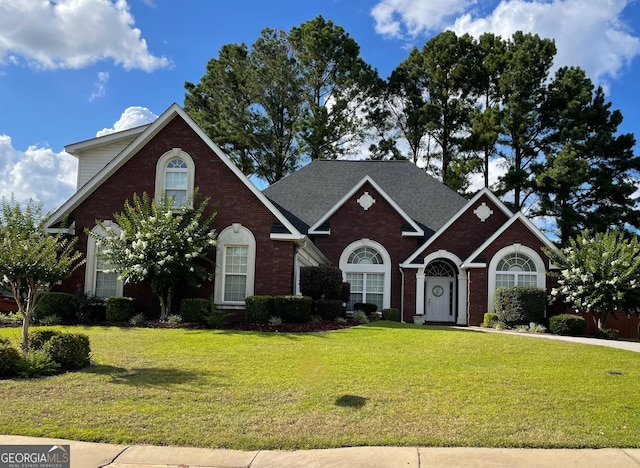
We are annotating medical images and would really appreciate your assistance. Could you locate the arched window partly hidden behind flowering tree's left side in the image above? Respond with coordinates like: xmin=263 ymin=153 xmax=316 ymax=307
xmin=84 ymin=221 xmax=124 ymax=299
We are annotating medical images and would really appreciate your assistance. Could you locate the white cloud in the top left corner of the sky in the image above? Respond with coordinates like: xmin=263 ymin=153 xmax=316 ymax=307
xmin=0 ymin=0 xmax=170 ymax=72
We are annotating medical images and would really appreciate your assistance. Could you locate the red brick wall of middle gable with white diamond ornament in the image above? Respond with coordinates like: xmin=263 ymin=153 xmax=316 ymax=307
xmin=314 ymin=183 xmax=417 ymax=309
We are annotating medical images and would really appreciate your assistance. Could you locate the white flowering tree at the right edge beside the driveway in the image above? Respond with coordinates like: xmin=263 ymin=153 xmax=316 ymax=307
xmin=546 ymin=231 xmax=640 ymax=328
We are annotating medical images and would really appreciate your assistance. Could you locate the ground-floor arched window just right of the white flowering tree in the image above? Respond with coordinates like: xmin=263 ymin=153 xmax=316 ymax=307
xmin=214 ymin=223 xmax=256 ymax=306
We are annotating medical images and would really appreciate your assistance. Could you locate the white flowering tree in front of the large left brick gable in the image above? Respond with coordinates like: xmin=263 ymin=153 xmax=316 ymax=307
xmin=87 ymin=193 xmax=216 ymax=321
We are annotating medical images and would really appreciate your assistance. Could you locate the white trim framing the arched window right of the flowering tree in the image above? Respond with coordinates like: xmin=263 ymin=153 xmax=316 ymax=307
xmin=213 ymin=223 xmax=256 ymax=306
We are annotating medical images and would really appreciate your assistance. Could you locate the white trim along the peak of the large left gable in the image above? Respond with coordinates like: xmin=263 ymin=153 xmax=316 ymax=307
xmin=47 ymin=103 xmax=304 ymax=240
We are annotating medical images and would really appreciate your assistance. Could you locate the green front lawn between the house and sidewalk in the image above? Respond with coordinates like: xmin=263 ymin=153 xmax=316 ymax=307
xmin=0 ymin=322 xmax=640 ymax=449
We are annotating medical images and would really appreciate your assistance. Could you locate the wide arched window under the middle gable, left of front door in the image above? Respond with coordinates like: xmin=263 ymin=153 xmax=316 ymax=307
xmin=340 ymin=239 xmax=391 ymax=311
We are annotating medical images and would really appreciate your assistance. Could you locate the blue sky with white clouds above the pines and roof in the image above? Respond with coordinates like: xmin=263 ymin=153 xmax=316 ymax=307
xmin=0 ymin=0 xmax=640 ymax=214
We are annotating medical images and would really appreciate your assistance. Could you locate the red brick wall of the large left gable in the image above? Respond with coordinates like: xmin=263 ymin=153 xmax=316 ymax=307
xmin=62 ymin=117 xmax=295 ymax=317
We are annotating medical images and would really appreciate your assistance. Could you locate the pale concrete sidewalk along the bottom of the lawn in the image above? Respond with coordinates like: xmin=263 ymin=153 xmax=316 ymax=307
xmin=0 ymin=435 xmax=640 ymax=468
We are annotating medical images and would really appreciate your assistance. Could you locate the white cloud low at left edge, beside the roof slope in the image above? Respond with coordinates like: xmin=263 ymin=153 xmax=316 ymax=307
xmin=0 ymin=134 xmax=78 ymax=212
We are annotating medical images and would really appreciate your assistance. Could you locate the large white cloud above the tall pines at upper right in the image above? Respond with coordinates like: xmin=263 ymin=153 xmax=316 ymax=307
xmin=371 ymin=0 xmax=640 ymax=84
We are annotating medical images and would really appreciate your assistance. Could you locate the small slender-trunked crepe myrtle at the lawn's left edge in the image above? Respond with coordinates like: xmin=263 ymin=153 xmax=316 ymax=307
xmin=0 ymin=196 xmax=84 ymax=353
